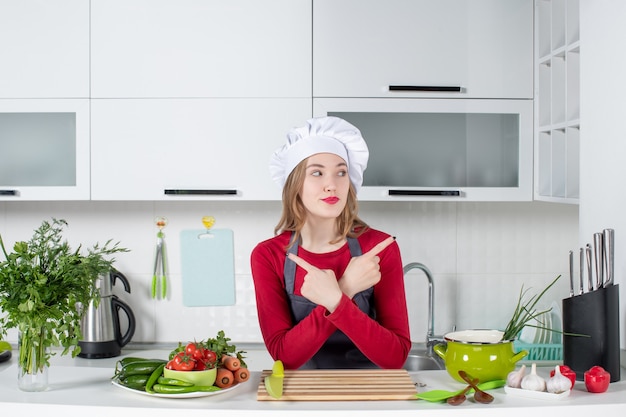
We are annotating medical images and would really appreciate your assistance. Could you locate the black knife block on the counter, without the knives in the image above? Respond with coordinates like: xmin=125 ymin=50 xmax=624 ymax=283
xmin=563 ymin=285 xmax=620 ymax=382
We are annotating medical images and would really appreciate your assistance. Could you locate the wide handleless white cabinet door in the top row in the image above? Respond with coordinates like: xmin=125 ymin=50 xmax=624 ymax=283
xmin=91 ymin=0 xmax=312 ymax=98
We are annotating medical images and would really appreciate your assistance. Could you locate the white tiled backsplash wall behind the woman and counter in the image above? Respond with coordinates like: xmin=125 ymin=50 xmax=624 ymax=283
xmin=0 ymin=201 xmax=578 ymax=343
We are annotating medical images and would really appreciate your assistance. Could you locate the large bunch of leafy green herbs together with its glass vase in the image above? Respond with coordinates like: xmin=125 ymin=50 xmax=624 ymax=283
xmin=0 ymin=219 xmax=128 ymax=391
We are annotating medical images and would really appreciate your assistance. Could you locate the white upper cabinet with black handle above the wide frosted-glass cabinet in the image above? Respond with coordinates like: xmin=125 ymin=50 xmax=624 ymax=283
xmin=313 ymin=0 xmax=533 ymax=99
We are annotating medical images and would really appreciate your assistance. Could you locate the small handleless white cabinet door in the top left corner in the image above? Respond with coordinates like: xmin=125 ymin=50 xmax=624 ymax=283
xmin=0 ymin=0 xmax=89 ymax=98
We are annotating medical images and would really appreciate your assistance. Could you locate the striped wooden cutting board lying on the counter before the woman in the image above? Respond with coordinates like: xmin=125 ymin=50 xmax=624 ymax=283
xmin=257 ymin=369 xmax=417 ymax=401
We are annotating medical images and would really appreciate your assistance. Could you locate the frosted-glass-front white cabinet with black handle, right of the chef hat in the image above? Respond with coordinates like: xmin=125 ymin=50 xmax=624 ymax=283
xmin=313 ymin=98 xmax=533 ymax=201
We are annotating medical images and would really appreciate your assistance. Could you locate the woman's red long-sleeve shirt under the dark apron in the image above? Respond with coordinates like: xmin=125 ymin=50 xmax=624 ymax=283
xmin=251 ymin=229 xmax=411 ymax=369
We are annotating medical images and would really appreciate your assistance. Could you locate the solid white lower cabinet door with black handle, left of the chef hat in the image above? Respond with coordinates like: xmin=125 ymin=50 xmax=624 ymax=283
xmin=91 ymin=99 xmax=311 ymax=201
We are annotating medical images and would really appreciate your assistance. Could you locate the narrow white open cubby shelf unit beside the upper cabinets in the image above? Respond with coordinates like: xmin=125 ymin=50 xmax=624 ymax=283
xmin=534 ymin=0 xmax=580 ymax=204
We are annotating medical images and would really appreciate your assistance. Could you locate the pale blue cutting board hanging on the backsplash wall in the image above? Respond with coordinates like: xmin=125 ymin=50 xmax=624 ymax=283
xmin=180 ymin=229 xmax=235 ymax=307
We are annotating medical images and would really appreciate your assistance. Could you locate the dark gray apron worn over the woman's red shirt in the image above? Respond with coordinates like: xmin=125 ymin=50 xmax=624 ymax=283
xmin=284 ymin=234 xmax=377 ymax=369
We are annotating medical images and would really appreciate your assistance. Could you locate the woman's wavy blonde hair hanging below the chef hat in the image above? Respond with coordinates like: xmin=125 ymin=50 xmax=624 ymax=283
xmin=274 ymin=159 xmax=368 ymax=248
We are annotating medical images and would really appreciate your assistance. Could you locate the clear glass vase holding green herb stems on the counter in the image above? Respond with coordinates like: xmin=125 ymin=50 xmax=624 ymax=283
xmin=17 ymin=326 xmax=49 ymax=392
